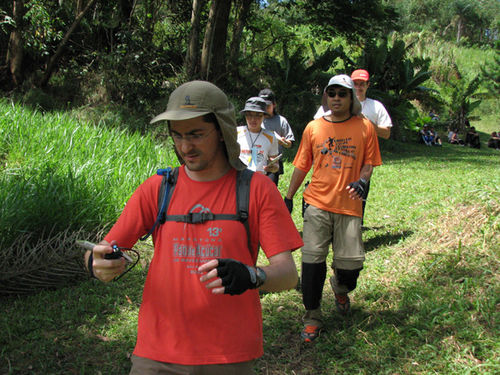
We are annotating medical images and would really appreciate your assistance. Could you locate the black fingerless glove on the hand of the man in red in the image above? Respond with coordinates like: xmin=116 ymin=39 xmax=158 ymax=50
xmin=217 ymin=259 xmax=255 ymax=296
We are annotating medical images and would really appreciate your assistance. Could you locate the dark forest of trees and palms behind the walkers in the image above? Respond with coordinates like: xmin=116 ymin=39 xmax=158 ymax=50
xmin=0 ymin=0 xmax=500 ymax=140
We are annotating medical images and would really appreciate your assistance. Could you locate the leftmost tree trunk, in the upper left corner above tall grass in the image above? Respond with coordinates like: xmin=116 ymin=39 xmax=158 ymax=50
xmin=6 ymin=0 xmax=25 ymax=86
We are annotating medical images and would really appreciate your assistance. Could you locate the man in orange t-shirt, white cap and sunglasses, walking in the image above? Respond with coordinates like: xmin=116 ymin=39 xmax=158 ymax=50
xmin=285 ymin=74 xmax=382 ymax=342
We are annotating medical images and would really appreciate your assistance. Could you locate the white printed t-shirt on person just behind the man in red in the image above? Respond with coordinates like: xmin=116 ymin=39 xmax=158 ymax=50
xmin=237 ymin=126 xmax=278 ymax=173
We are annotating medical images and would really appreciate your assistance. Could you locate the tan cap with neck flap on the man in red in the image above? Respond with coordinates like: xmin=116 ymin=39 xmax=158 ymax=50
xmin=150 ymin=81 xmax=246 ymax=170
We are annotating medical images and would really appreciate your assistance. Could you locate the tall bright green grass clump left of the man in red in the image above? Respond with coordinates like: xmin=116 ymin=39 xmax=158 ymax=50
xmin=0 ymin=101 xmax=175 ymax=292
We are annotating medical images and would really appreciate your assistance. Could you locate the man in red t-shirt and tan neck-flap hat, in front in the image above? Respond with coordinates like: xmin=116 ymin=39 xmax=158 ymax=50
xmin=86 ymin=81 xmax=303 ymax=375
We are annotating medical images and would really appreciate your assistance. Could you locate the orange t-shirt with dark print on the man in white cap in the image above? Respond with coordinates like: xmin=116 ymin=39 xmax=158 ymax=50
xmin=293 ymin=116 xmax=382 ymax=217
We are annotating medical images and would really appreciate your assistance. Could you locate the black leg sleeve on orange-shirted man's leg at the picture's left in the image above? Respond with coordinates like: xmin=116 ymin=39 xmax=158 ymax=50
xmin=301 ymin=262 xmax=326 ymax=310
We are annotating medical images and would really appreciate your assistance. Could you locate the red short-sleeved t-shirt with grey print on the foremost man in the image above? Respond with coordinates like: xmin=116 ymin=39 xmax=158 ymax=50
xmin=105 ymin=167 xmax=303 ymax=365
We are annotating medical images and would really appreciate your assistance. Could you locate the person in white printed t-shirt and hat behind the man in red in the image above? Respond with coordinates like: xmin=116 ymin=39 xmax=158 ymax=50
xmin=237 ymin=97 xmax=279 ymax=174
